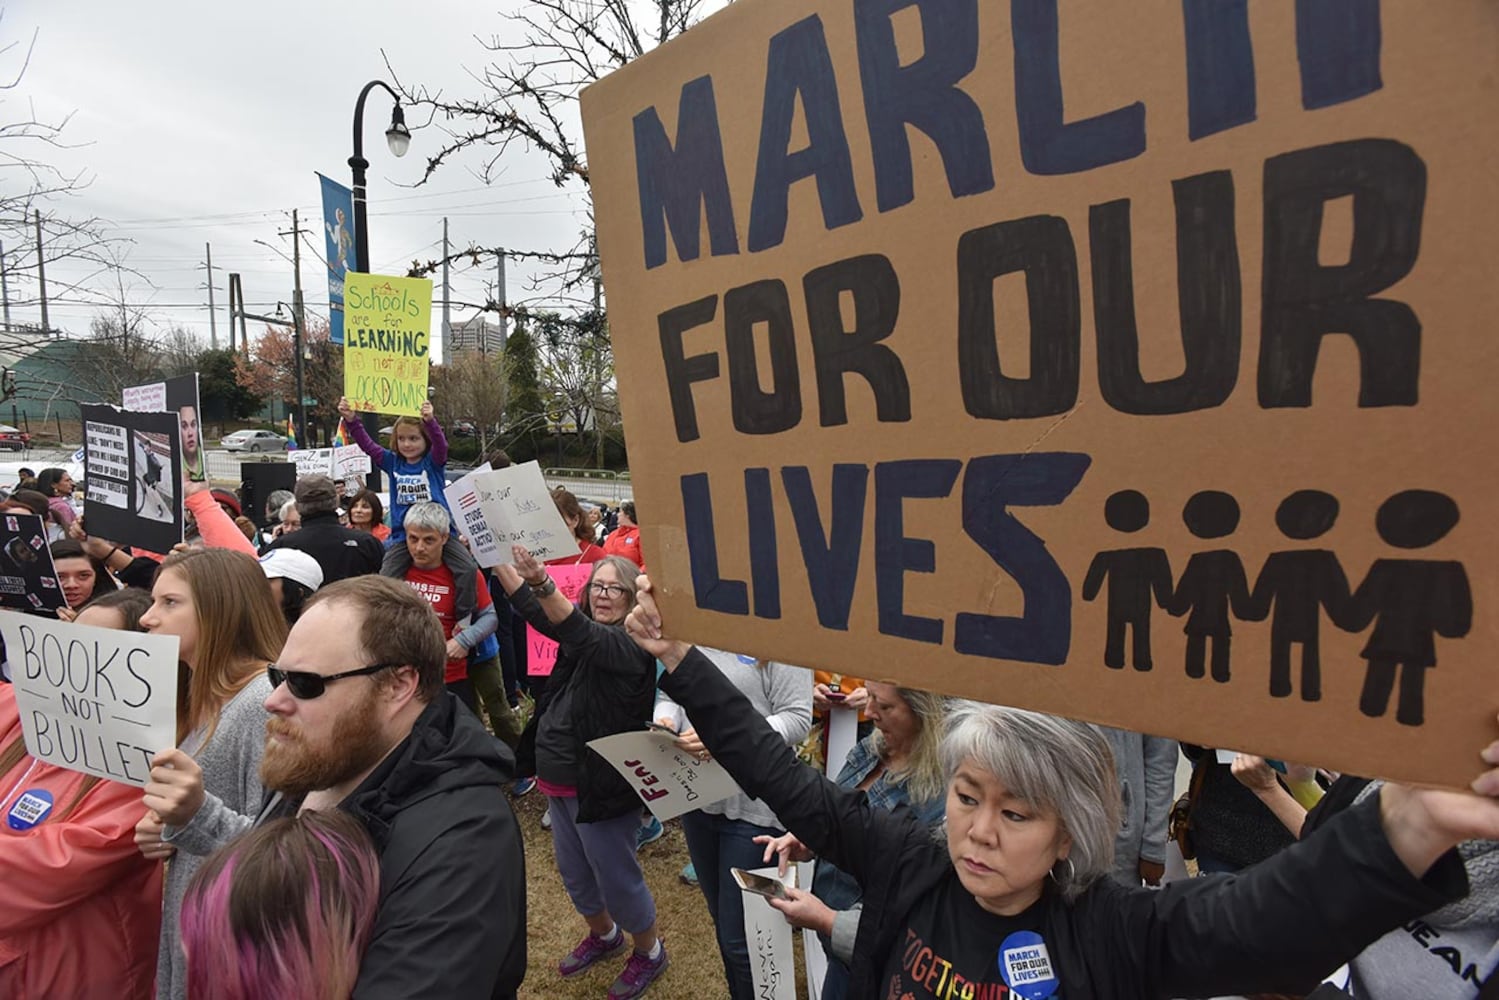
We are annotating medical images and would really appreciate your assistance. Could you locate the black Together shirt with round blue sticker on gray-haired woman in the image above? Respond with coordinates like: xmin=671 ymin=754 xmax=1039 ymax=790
xmin=878 ymin=876 xmax=1064 ymax=1000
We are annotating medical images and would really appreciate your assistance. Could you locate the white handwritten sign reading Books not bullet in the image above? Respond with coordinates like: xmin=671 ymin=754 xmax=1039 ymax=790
xmin=0 ymin=612 xmax=177 ymax=786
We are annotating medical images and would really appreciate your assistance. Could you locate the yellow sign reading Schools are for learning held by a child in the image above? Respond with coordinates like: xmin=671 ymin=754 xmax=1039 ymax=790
xmin=343 ymin=271 xmax=432 ymax=417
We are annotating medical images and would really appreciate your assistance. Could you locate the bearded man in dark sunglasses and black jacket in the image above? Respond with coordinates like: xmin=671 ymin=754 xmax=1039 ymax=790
xmin=258 ymin=576 xmax=526 ymax=1000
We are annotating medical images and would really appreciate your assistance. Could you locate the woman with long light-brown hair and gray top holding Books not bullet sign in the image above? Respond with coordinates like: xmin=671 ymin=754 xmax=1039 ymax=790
xmin=135 ymin=549 xmax=286 ymax=1000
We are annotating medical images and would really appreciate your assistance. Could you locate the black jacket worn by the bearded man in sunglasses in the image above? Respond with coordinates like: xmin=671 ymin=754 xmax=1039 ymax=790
xmin=259 ymin=691 xmax=526 ymax=1000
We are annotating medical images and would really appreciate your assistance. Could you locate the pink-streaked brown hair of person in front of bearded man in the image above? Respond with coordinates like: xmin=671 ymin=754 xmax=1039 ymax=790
xmin=181 ymin=811 xmax=379 ymax=1000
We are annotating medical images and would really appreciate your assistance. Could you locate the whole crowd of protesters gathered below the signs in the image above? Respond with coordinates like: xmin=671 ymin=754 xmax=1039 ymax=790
xmin=0 ymin=400 xmax=1499 ymax=1000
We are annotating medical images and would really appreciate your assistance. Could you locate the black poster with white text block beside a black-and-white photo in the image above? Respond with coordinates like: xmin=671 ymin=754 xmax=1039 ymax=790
xmin=81 ymin=405 xmax=183 ymax=552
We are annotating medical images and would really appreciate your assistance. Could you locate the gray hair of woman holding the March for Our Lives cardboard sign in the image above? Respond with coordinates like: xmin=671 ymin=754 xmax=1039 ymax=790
xmin=941 ymin=702 xmax=1121 ymax=903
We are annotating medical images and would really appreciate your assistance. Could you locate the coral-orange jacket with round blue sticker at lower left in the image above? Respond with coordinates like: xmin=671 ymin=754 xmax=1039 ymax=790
xmin=0 ymin=684 xmax=162 ymax=1000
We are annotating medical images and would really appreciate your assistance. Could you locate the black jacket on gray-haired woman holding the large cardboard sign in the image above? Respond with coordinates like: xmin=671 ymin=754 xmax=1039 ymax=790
xmin=661 ymin=649 xmax=1468 ymax=1000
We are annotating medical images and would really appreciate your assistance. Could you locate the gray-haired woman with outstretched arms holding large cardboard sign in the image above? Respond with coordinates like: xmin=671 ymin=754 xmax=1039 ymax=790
xmin=627 ymin=577 xmax=1499 ymax=1000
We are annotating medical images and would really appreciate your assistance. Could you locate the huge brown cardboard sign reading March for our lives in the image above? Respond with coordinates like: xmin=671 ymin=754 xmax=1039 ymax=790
xmin=583 ymin=0 xmax=1499 ymax=784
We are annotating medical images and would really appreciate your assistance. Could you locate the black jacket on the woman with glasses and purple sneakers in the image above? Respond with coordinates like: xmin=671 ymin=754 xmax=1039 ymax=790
xmin=510 ymin=586 xmax=655 ymax=823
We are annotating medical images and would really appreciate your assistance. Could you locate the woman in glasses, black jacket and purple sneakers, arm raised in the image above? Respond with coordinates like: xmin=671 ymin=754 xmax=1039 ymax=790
xmin=495 ymin=546 xmax=667 ymax=1000
